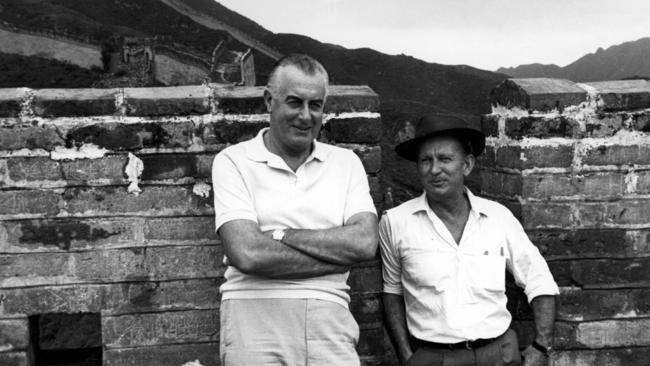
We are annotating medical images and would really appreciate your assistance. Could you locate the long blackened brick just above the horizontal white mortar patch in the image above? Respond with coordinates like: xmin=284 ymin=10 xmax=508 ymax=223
xmin=66 ymin=122 xmax=193 ymax=151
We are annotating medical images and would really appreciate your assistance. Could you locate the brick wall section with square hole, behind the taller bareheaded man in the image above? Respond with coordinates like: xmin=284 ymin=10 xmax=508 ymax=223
xmin=0 ymin=85 xmax=384 ymax=366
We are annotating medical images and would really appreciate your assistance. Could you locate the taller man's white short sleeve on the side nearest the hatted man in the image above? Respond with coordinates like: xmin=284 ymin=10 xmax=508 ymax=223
xmin=343 ymin=151 xmax=377 ymax=222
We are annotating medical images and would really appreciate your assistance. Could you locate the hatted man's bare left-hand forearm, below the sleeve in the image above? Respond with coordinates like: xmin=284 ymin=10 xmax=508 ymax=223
xmin=382 ymin=293 xmax=413 ymax=364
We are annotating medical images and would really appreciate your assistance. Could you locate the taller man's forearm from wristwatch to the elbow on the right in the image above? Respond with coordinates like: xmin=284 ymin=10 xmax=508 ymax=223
xmin=282 ymin=212 xmax=379 ymax=266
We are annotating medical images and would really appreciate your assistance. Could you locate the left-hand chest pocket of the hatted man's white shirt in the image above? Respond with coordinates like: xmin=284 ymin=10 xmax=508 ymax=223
xmin=402 ymin=250 xmax=457 ymax=292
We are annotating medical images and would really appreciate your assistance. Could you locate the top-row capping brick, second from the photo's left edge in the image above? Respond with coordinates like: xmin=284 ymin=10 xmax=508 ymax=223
xmin=32 ymin=89 xmax=119 ymax=117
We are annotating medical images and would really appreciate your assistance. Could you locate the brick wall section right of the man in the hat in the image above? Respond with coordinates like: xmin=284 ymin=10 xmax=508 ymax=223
xmin=480 ymin=79 xmax=650 ymax=366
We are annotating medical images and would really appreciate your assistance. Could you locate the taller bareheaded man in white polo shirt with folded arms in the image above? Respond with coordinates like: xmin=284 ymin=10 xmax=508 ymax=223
xmin=212 ymin=55 xmax=378 ymax=366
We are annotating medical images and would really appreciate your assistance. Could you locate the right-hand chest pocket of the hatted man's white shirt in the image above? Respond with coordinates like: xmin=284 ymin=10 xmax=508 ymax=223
xmin=466 ymin=255 xmax=506 ymax=292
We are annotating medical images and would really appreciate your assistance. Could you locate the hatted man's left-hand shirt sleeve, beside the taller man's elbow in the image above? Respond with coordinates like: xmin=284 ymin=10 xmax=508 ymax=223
xmin=379 ymin=214 xmax=403 ymax=295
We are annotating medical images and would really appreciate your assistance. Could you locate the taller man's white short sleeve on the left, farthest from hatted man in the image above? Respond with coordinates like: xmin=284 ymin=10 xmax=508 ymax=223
xmin=212 ymin=151 xmax=257 ymax=230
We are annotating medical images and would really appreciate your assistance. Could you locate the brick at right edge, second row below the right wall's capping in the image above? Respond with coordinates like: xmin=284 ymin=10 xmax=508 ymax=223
xmin=582 ymin=144 xmax=650 ymax=165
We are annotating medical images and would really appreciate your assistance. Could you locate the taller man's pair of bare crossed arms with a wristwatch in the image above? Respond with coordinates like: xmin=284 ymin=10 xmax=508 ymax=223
xmin=219 ymin=212 xmax=378 ymax=279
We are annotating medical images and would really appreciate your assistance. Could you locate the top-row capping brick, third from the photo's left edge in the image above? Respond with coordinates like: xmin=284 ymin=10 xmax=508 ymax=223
xmin=124 ymin=85 xmax=211 ymax=116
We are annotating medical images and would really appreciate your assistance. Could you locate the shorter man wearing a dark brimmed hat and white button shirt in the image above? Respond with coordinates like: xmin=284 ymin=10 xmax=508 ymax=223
xmin=379 ymin=115 xmax=559 ymax=366
